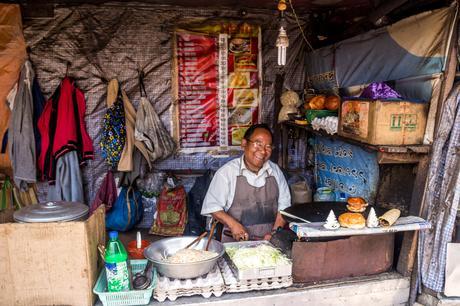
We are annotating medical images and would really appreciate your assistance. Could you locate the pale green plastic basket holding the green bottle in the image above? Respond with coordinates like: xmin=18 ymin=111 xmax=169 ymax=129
xmin=93 ymin=259 xmax=157 ymax=306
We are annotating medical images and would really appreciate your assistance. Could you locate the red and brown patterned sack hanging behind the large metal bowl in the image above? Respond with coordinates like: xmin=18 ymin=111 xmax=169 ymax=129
xmin=149 ymin=185 xmax=187 ymax=236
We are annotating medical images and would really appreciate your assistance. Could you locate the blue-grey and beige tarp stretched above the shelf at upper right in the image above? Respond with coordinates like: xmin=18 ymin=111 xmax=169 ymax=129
xmin=306 ymin=3 xmax=458 ymax=144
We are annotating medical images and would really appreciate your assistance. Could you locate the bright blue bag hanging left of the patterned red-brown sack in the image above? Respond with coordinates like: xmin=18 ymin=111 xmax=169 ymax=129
xmin=105 ymin=187 xmax=144 ymax=232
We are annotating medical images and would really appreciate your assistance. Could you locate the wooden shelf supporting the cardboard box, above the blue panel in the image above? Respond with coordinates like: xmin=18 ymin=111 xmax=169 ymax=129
xmin=283 ymin=121 xmax=431 ymax=166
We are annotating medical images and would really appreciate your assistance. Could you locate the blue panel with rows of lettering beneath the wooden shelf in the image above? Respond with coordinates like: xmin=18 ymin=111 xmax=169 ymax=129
xmin=314 ymin=136 xmax=379 ymax=204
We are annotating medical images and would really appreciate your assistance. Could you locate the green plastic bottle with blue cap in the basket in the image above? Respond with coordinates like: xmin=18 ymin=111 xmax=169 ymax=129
xmin=105 ymin=231 xmax=130 ymax=292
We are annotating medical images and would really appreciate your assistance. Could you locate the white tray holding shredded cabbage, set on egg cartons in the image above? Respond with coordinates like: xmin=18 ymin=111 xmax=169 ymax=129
xmin=224 ymin=240 xmax=292 ymax=281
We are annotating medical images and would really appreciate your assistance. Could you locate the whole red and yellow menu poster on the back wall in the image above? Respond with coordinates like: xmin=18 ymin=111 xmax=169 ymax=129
xmin=173 ymin=22 xmax=261 ymax=153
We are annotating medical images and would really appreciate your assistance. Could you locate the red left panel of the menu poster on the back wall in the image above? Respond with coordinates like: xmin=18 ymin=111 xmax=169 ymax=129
xmin=177 ymin=33 xmax=219 ymax=148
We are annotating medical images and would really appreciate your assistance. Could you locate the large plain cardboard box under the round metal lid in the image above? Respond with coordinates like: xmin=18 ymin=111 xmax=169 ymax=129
xmin=0 ymin=206 xmax=105 ymax=306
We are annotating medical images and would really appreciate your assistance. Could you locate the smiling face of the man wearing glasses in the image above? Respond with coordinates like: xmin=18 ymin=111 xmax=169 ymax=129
xmin=241 ymin=128 xmax=272 ymax=173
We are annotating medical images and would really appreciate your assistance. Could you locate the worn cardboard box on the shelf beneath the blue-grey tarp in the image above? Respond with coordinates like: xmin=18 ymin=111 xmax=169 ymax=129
xmin=338 ymin=100 xmax=428 ymax=145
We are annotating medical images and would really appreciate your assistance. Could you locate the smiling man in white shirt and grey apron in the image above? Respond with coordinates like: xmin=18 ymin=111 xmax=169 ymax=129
xmin=201 ymin=124 xmax=291 ymax=242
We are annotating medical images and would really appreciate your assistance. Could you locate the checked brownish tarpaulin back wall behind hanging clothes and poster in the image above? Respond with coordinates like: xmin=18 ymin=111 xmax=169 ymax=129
xmin=24 ymin=3 xmax=305 ymax=202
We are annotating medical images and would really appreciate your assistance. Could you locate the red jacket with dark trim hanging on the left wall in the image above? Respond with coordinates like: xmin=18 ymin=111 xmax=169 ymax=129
xmin=37 ymin=77 xmax=93 ymax=182
